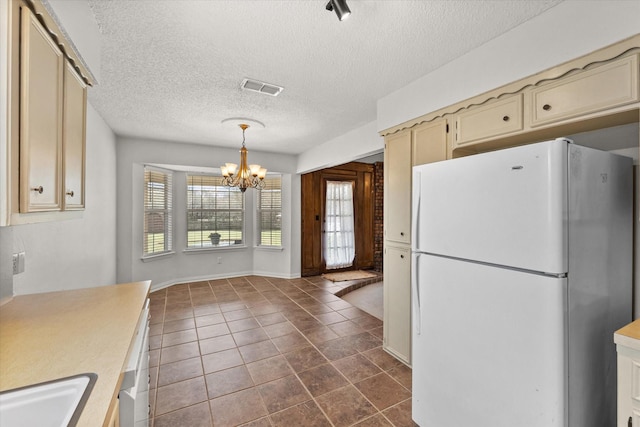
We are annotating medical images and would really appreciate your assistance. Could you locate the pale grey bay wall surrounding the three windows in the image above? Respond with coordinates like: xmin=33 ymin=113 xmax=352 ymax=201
xmin=117 ymin=138 xmax=301 ymax=289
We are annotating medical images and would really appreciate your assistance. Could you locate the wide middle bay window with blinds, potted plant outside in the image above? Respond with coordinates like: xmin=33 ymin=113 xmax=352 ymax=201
xmin=187 ymin=175 xmax=244 ymax=248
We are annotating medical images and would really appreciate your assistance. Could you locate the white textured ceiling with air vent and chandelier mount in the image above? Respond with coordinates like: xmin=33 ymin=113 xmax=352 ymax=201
xmin=88 ymin=0 xmax=562 ymax=153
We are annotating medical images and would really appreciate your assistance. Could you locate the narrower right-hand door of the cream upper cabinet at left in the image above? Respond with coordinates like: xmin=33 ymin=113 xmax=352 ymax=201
xmin=63 ymin=61 xmax=87 ymax=210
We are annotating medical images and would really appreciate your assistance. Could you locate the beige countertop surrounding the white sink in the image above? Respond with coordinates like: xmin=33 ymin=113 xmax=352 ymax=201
xmin=0 ymin=281 xmax=151 ymax=427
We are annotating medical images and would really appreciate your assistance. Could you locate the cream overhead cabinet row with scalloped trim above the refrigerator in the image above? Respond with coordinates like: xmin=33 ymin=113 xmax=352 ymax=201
xmin=380 ymin=34 xmax=640 ymax=160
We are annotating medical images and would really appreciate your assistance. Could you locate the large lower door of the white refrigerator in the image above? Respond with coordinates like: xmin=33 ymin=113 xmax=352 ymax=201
xmin=412 ymin=255 xmax=567 ymax=427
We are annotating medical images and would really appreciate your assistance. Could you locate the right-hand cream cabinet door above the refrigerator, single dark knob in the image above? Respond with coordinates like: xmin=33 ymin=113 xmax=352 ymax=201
xmin=531 ymin=54 xmax=640 ymax=127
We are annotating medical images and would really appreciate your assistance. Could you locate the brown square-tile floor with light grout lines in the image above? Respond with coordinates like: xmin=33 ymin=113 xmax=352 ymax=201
xmin=150 ymin=276 xmax=415 ymax=427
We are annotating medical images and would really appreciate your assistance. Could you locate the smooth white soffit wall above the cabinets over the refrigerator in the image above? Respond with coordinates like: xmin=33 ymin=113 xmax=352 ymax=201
xmin=377 ymin=0 xmax=640 ymax=130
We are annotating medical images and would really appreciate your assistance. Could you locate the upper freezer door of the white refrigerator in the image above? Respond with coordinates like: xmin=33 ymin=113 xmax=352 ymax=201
xmin=412 ymin=140 xmax=567 ymax=274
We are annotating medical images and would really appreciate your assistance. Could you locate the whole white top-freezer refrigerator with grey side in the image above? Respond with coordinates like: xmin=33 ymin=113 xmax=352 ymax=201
xmin=412 ymin=138 xmax=633 ymax=427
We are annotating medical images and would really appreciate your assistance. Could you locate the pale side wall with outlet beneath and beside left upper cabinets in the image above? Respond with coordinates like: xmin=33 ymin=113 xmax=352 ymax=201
xmin=11 ymin=105 xmax=116 ymax=295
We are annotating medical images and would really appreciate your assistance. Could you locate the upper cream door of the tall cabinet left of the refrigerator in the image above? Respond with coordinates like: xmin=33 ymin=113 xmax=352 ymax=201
xmin=384 ymin=131 xmax=411 ymax=244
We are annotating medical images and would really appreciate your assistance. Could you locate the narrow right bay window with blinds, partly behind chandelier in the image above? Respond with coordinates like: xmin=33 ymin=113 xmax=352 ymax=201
xmin=256 ymin=175 xmax=282 ymax=247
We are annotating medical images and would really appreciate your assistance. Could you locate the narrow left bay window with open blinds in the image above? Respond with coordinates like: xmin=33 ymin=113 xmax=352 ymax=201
xmin=142 ymin=166 xmax=173 ymax=256
